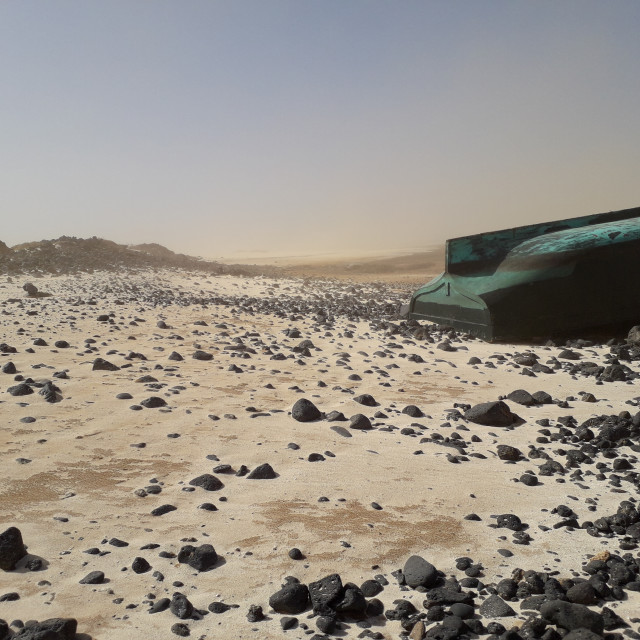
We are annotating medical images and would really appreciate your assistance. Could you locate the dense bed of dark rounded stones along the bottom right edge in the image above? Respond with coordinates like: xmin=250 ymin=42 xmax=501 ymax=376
xmin=254 ymin=554 xmax=640 ymax=640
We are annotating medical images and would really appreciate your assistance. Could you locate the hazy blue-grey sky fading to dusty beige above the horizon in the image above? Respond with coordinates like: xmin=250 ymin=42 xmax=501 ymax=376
xmin=0 ymin=0 xmax=640 ymax=258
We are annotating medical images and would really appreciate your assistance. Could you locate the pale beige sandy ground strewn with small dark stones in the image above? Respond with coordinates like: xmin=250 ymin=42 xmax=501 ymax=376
xmin=0 ymin=272 xmax=640 ymax=640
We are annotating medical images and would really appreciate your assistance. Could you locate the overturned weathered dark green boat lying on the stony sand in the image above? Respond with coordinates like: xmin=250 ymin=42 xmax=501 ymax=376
xmin=409 ymin=208 xmax=640 ymax=341
